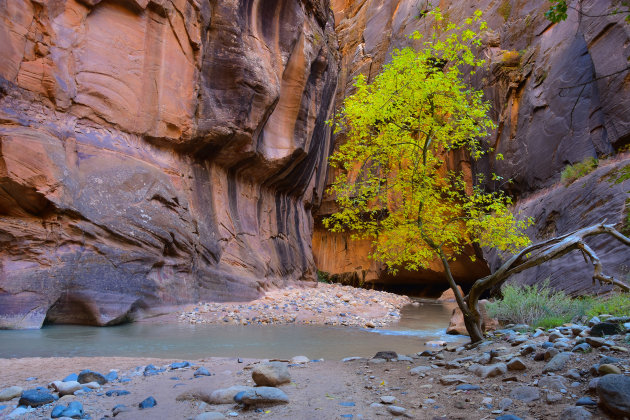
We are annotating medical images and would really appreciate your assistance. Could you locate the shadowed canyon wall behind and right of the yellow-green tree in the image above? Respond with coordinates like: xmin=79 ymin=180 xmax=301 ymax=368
xmin=314 ymin=0 xmax=630 ymax=294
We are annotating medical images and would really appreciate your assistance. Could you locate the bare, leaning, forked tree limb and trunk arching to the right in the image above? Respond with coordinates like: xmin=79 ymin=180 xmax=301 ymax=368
xmin=447 ymin=223 xmax=630 ymax=343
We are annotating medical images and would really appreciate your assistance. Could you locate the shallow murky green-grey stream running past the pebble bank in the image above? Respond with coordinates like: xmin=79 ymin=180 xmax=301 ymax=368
xmin=0 ymin=301 xmax=468 ymax=360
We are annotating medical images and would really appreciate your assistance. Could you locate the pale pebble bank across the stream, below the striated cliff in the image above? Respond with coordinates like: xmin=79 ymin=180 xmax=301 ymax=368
xmin=178 ymin=283 xmax=412 ymax=328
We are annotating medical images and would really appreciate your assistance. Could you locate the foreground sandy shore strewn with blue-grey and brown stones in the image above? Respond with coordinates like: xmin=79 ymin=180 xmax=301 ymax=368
xmin=0 ymin=317 xmax=630 ymax=420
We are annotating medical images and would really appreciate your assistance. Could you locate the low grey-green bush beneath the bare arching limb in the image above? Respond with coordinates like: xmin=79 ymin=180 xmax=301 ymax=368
xmin=486 ymin=280 xmax=592 ymax=328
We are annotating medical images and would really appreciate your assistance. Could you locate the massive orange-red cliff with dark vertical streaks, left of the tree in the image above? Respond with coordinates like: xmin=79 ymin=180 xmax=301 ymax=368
xmin=0 ymin=0 xmax=338 ymax=328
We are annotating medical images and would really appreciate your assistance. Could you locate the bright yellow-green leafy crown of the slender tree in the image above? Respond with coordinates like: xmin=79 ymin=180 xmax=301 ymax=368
xmin=324 ymin=9 xmax=531 ymax=272
